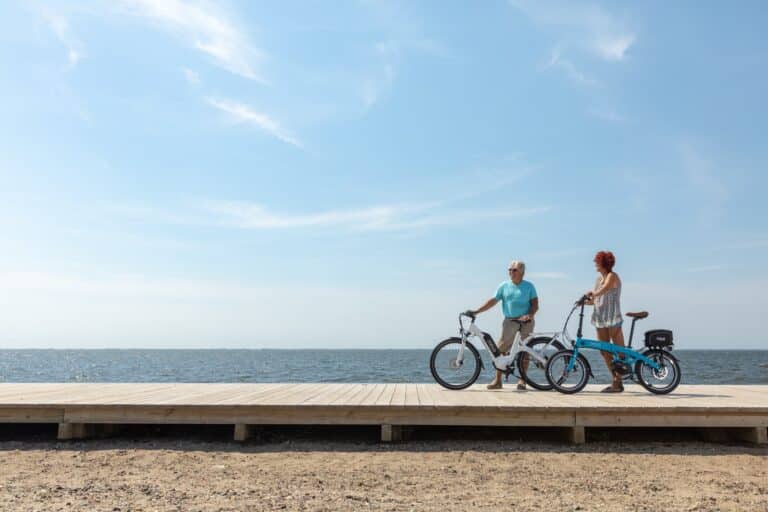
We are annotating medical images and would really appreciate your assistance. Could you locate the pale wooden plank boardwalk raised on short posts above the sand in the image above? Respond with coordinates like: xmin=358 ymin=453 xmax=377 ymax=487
xmin=0 ymin=383 xmax=768 ymax=443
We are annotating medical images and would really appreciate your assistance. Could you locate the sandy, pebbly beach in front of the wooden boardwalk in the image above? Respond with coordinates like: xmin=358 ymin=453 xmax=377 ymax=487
xmin=0 ymin=438 xmax=768 ymax=511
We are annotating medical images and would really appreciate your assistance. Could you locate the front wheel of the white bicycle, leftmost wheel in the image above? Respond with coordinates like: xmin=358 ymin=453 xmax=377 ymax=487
xmin=429 ymin=338 xmax=482 ymax=389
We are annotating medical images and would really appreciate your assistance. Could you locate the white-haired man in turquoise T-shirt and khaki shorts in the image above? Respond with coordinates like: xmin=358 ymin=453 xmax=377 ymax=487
xmin=472 ymin=260 xmax=539 ymax=390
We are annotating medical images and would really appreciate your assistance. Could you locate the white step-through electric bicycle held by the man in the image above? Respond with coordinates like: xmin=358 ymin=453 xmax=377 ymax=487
xmin=429 ymin=312 xmax=573 ymax=391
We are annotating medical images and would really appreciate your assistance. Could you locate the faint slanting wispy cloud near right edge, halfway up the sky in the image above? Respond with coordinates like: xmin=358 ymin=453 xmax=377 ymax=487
xmin=680 ymin=143 xmax=730 ymax=223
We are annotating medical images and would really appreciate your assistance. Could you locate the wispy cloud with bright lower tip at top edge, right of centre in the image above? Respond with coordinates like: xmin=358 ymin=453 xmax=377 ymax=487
xmin=509 ymin=0 xmax=637 ymax=62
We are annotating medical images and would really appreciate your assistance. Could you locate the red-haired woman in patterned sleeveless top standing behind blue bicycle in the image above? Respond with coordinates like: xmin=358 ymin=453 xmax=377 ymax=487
xmin=587 ymin=251 xmax=624 ymax=393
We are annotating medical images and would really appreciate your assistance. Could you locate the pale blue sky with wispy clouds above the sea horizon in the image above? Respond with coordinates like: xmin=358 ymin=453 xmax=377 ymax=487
xmin=0 ymin=0 xmax=768 ymax=348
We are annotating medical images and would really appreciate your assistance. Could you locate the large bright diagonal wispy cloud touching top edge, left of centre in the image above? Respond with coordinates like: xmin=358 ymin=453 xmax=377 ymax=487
xmin=121 ymin=0 xmax=265 ymax=82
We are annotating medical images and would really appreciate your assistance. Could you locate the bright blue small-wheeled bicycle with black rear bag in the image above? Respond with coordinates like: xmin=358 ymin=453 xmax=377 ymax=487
xmin=546 ymin=295 xmax=680 ymax=395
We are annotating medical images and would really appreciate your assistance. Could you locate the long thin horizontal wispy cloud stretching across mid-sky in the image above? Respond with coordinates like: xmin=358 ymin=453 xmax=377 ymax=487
xmin=205 ymin=201 xmax=549 ymax=231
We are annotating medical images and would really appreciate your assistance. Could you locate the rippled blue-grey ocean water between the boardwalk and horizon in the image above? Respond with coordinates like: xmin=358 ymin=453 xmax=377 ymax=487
xmin=0 ymin=349 xmax=768 ymax=384
